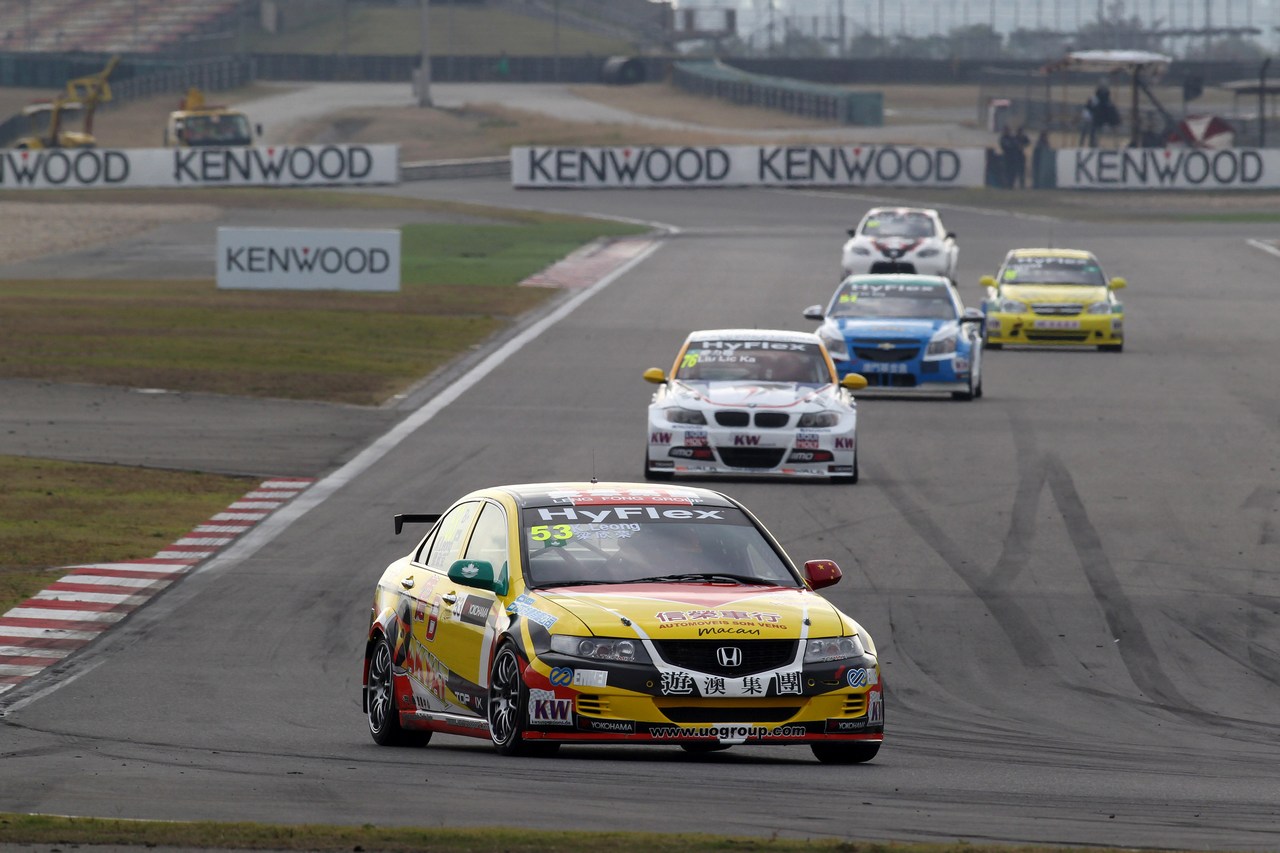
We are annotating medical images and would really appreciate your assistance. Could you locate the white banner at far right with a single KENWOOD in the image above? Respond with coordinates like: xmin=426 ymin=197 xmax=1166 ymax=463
xmin=1057 ymin=149 xmax=1280 ymax=190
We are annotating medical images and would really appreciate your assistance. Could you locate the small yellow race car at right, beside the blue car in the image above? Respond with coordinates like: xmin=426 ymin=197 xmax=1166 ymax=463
xmin=979 ymin=248 xmax=1125 ymax=352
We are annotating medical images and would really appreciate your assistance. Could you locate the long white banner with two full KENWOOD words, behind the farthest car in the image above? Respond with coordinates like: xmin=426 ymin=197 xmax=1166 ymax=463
xmin=511 ymin=145 xmax=986 ymax=188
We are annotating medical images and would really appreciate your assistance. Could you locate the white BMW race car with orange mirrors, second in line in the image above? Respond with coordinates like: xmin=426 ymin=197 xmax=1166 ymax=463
xmin=644 ymin=329 xmax=867 ymax=483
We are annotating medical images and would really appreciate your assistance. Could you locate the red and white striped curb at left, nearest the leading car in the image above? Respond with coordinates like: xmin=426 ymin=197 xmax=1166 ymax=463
xmin=0 ymin=478 xmax=314 ymax=693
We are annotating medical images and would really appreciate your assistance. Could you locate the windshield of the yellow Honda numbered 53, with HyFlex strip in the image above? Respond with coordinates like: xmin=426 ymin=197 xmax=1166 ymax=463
xmin=521 ymin=503 xmax=800 ymax=588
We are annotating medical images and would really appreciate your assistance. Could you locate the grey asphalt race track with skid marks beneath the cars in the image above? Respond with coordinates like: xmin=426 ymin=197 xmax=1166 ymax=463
xmin=0 ymin=167 xmax=1280 ymax=850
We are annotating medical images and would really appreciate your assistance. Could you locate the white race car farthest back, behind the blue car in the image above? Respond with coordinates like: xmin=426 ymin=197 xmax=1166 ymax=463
xmin=840 ymin=207 xmax=960 ymax=282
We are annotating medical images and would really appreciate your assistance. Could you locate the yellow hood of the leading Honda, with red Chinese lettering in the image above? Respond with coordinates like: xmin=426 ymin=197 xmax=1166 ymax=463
xmin=534 ymin=583 xmax=854 ymax=639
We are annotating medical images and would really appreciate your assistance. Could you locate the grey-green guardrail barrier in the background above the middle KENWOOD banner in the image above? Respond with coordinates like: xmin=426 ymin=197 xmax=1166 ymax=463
xmin=672 ymin=61 xmax=884 ymax=127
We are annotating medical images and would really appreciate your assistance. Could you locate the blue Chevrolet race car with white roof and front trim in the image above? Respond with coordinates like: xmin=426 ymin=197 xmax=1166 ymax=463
xmin=804 ymin=275 xmax=983 ymax=400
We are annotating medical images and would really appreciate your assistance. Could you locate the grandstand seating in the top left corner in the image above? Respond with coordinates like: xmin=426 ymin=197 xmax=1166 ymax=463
xmin=0 ymin=0 xmax=242 ymax=54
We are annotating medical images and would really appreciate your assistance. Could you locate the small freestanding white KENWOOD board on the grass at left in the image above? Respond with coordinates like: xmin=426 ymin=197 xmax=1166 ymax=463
xmin=218 ymin=228 xmax=401 ymax=291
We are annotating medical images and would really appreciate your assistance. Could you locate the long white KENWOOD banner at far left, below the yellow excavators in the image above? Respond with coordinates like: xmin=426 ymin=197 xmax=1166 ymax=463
xmin=0 ymin=145 xmax=399 ymax=190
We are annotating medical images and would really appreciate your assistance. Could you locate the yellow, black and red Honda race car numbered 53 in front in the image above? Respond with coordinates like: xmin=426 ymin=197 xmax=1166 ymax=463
xmin=364 ymin=483 xmax=884 ymax=763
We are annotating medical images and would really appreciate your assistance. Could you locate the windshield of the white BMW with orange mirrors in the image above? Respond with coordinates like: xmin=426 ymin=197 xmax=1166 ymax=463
xmin=676 ymin=339 xmax=833 ymax=384
